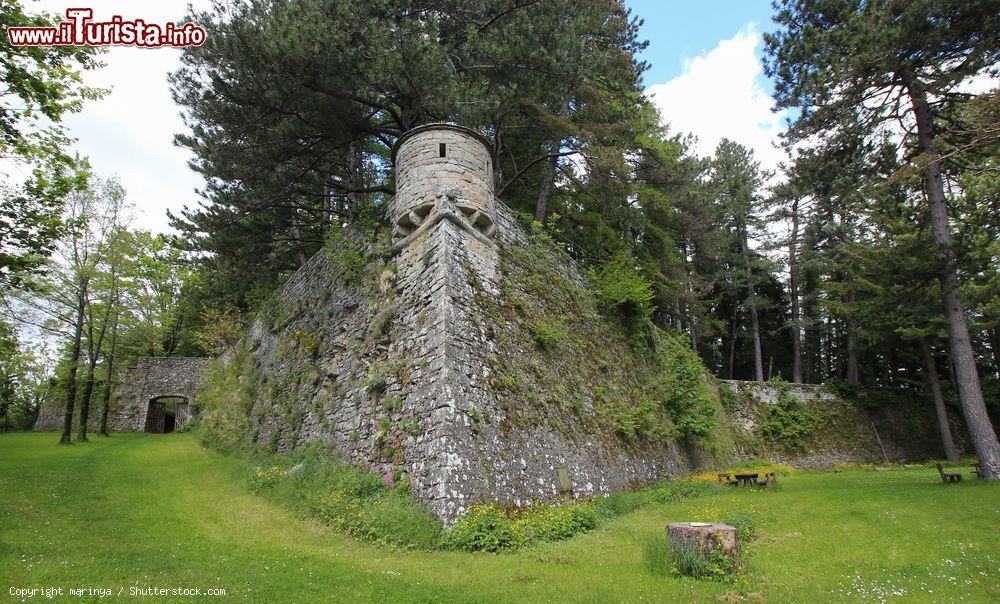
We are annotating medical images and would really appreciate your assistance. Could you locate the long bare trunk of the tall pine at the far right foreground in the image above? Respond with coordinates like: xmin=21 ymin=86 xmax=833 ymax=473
xmin=902 ymin=74 xmax=1000 ymax=480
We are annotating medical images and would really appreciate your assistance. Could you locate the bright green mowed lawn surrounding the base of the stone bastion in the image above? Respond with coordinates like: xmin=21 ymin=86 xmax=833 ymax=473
xmin=0 ymin=434 xmax=1000 ymax=602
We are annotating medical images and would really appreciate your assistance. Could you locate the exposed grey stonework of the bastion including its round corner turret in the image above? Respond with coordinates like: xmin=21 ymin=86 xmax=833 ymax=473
xmin=234 ymin=125 xmax=944 ymax=521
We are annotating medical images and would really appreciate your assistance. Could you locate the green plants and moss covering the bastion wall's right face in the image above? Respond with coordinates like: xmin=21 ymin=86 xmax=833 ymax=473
xmin=480 ymin=227 xmax=725 ymax=450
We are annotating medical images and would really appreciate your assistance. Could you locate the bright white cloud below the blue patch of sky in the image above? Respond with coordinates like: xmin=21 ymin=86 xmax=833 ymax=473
xmin=646 ymin=23 xmax=784 ymax=169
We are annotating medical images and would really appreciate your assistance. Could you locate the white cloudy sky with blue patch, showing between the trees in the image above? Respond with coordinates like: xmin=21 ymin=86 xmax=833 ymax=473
xmin=26 ymin=0 xmax=783 ymax=231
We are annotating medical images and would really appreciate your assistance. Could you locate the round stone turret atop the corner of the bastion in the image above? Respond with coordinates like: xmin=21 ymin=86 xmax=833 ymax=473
xmin=389 ymin=124 xmax=494 ymax=241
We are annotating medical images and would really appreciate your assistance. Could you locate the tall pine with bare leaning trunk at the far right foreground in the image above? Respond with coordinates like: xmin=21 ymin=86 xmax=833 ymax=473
xmin=765 ymin=0 xmax=1000 ymax=479
